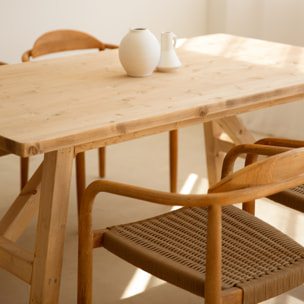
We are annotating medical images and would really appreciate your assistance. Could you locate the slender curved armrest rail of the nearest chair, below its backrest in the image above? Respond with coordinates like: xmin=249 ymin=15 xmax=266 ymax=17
xmin=80 ymin=175 xmax=304 ymax=214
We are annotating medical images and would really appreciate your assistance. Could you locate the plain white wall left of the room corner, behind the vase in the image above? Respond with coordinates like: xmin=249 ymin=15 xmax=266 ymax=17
xmin=0 ymin=0 xmax=206 ymax=63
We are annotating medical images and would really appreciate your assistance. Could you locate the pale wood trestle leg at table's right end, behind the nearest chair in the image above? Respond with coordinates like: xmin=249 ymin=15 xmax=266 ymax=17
xmin=204 ymin=116 xmax=255 ymax=186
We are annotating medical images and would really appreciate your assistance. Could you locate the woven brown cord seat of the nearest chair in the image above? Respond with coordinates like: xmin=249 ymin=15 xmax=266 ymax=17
xmin=103 ymin=206 xmax=304 ymax=304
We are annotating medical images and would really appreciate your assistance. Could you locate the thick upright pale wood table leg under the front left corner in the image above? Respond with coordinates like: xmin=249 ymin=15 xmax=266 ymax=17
xmin=30 ymin=149 xmax=74 ymax=304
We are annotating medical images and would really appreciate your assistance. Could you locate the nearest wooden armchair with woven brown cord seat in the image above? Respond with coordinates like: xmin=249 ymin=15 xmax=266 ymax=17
xmin=78 ymin=145 xmax=304 ymax=304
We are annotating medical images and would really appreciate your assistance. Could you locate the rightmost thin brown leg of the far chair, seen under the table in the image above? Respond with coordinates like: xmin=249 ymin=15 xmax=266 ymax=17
xmin=169 ymin=130 xmax=178 ymax=193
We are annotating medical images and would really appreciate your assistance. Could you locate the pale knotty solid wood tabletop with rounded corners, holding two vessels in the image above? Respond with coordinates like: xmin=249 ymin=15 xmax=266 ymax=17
xmin=0 ymin=34 xmax=304 ymax=156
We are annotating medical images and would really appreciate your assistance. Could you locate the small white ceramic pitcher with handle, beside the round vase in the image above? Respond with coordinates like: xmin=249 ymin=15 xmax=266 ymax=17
xmin=157 ymin=32 xmax=181 ymax=72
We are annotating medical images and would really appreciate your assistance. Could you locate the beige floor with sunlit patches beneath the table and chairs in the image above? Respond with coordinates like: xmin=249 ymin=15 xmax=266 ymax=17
xmin=0 ymin=126 xmax=304 ymax=304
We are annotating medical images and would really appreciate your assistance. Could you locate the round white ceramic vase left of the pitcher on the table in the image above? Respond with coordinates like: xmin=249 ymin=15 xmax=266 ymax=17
xmin=119 ymin=28 xmax=160 ymax=77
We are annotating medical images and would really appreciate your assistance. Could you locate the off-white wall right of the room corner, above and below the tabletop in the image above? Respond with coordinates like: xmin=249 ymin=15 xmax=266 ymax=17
xmin=207 ymin=0 xmax=304 ymax=139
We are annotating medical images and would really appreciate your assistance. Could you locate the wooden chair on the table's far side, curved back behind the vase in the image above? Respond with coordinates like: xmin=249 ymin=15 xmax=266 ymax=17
xmin=21 ymin=30 xmax=177 ymax=207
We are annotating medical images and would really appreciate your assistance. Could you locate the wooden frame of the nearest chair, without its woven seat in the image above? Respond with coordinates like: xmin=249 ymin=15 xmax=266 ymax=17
xmin=78 ymin=145 xmax=304 ymax=304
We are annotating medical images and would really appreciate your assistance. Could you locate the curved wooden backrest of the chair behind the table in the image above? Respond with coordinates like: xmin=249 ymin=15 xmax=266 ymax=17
xmin=22 ymin=30 xmax=118 ymax=62
